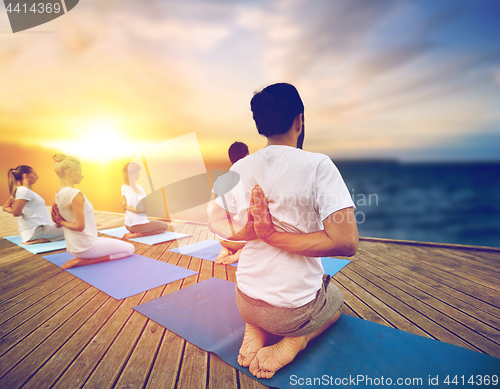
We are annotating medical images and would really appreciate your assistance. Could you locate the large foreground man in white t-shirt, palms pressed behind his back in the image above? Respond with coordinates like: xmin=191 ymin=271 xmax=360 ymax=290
xmin=209 ymin=84 xmax=358 ymax=378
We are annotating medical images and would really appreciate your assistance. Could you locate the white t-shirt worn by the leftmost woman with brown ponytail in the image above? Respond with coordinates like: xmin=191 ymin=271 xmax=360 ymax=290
xmin=15 ymin=186 xmax=53 ymax=242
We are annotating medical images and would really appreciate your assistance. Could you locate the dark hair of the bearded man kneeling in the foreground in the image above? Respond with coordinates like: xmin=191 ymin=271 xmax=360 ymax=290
xmin=250 ymin=83 xmax=304 ymax=137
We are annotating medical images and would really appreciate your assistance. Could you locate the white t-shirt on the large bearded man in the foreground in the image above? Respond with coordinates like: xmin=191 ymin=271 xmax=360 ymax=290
xmin=216 ymin=145 xmax=354 ymax=308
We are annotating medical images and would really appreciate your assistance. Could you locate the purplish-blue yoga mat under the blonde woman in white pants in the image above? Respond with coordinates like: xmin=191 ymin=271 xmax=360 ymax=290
xmin=44 ymin=252 xmax=198 ymax=300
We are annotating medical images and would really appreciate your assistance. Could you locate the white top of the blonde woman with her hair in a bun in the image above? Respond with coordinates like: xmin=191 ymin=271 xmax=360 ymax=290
xmin=56 ymin=186 xmax=97 ymax=254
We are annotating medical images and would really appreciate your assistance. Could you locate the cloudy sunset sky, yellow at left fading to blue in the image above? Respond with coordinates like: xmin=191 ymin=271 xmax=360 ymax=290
xmin=0 ymin=0 xmax=500 ymax=211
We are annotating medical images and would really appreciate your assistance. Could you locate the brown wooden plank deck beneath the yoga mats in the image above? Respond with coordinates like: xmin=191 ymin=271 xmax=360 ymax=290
xmin=0 ymin=212 xmax=500 ymax=389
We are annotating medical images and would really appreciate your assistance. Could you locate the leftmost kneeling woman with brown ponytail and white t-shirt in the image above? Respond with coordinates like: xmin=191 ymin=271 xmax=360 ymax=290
xmin=2 ymin=165 xmax=64 ymax=244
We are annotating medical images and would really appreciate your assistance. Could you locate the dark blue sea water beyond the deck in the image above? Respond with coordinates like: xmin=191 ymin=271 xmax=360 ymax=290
xmin=334 ymin=160 xmax=500 ymax=247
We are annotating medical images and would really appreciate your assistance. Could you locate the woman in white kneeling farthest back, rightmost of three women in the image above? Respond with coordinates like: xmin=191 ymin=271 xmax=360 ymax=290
xmin=122 ymin=162 xmax=168 ymax=239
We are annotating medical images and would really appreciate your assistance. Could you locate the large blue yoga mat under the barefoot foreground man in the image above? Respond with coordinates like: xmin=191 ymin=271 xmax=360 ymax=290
xmin=134 ymin=278 xmax=500 ymax=388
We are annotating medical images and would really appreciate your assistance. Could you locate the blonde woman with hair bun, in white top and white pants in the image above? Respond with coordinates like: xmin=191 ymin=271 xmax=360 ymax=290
xmin=52 ymin=154 xmax=135 ymax=269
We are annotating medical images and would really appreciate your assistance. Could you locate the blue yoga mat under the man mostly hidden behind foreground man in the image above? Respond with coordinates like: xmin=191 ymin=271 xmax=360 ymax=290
xmin=169 ymin=240 xmax=351 ymax=276
